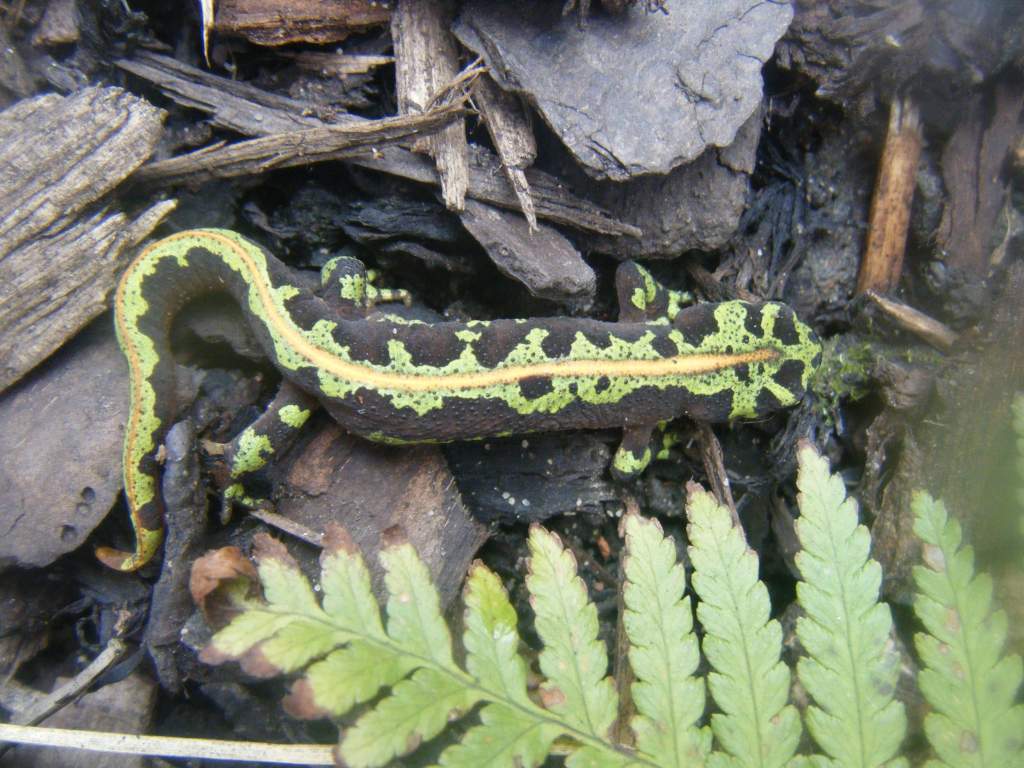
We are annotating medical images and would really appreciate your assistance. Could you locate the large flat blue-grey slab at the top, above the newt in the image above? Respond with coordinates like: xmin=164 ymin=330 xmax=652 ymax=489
xmin=455 ymin=0 xmax=793 ymax=181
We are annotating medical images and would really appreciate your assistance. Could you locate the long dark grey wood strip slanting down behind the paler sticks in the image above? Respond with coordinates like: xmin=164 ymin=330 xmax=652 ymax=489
xmin=119 ymin=53 xmax=641 ymax=237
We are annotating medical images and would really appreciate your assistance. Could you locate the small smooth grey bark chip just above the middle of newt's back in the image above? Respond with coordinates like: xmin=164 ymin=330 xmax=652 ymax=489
xmin=460 ymin=200 xmax=597 ymax=306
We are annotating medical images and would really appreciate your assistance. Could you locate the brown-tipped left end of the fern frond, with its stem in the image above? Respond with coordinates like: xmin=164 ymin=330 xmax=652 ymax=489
xmin=209 ymin=528 xmax=654 ymax=768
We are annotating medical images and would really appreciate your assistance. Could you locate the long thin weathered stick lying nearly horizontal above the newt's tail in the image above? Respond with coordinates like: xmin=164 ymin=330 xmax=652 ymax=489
xmin=133 ymin=103 xmax=465 ymax=184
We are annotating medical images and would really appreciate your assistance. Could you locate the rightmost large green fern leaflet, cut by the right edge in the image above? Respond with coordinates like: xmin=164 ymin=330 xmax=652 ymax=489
xmin=911 ymin=492 xmax=1024 ymax=768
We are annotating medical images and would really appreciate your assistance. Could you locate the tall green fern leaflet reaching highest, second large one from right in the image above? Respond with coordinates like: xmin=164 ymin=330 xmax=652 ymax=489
xmin=796 ymin=443 xmax=906 ymax=768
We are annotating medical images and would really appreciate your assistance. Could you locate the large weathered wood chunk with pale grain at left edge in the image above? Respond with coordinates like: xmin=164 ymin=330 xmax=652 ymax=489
xmin=0 ymin=88 xmax=174 ymax=390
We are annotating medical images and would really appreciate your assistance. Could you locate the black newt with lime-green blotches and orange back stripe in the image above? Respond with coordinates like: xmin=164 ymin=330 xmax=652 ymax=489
xmin=98 ymin=229 xmax=820 ymax=570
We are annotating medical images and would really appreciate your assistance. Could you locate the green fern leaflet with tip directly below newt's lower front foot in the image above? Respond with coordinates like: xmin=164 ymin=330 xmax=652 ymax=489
xmin=623 ymin=515 xmax=711 ymax=766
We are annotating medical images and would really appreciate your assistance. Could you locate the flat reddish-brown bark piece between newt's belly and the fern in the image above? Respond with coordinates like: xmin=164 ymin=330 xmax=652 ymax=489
xmin=272 ymin=420 xmax=487 ymax=605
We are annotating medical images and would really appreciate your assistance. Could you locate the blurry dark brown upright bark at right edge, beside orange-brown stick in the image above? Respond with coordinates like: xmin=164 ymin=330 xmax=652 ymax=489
xmin=936 ymin=78 xmax=1024 ymax=278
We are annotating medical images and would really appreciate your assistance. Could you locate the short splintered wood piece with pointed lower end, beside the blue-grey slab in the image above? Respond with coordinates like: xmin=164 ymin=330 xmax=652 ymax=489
xmin=473 ymin=75 xmax=537 ymax=229
